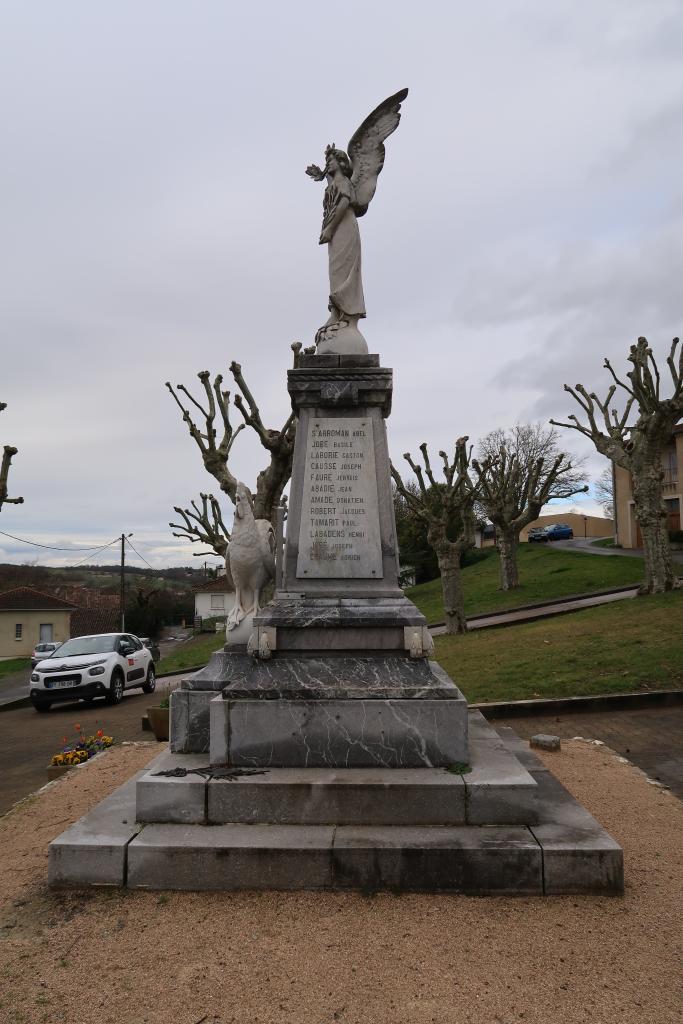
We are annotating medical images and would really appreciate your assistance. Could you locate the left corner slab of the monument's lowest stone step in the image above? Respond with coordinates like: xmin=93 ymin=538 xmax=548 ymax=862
xmin=47 ymin=772 xmax=144 ymax=888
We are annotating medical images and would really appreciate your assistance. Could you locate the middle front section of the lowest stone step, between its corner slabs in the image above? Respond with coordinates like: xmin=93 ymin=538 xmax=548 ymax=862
xmin=128 ymin=824 xmax=543 ymax=895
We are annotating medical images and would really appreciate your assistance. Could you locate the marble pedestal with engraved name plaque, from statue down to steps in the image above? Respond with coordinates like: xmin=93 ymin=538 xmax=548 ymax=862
xmin=171 ymin=354 xmax=469 ymax=768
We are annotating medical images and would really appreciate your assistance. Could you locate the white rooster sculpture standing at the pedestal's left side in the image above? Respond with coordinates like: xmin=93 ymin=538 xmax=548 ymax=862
xmin=225 ymin=482 xmax=275 ymax=632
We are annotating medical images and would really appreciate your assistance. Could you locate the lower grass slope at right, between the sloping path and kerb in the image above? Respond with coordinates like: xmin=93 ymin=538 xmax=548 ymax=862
xmin=435 ymin=585 xmax=683 ymax=701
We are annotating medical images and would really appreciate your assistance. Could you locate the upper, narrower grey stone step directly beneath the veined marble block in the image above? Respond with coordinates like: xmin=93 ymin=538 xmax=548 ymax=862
xmin=136 ymin=713 xmax=538 ymax=826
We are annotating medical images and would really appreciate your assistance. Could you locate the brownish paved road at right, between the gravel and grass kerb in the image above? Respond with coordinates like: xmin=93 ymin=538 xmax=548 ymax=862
xmin=492 ymin=707 xmax=683 ymax=800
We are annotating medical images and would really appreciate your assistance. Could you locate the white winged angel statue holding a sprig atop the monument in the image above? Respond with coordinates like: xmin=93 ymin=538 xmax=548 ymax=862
xmin=306 ymin=89 xmax=408 ymax=353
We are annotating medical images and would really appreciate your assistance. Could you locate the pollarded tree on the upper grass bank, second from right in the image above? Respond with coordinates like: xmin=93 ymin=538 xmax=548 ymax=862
xmin=472 ymin=423 xmax=588 ymax=590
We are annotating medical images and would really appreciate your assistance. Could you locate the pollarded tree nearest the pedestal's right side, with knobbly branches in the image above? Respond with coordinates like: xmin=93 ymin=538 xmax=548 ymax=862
xmin=391 ymin=437 xmax=479 ymax=633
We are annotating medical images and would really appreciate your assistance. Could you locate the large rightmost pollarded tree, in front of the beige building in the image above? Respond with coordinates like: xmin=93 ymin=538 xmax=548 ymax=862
xmin=551 ymin=338 xmax=683 ymax=594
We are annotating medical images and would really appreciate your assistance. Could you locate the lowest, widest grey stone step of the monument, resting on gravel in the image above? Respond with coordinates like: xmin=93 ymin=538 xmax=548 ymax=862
xmin=49 ymin=721 xmax=624 ymax=895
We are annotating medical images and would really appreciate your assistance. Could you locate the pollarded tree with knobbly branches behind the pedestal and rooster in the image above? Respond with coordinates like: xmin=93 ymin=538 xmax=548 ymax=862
xmin=166 ymin=342 xmax=301 ymax=557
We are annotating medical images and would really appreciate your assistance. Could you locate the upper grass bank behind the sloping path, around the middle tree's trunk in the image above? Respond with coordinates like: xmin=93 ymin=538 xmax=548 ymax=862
xmin=405 ymin=544 xmax=644 ymax=623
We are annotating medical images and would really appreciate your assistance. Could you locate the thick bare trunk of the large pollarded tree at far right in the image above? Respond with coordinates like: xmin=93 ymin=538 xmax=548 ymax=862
xmin=633 ymin=465 xmax=676 ymax=594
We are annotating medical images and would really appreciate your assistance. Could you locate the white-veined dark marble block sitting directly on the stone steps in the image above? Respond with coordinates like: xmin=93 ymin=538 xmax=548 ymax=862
xmin=171 ymin=651 xmax=467 ymax=767
